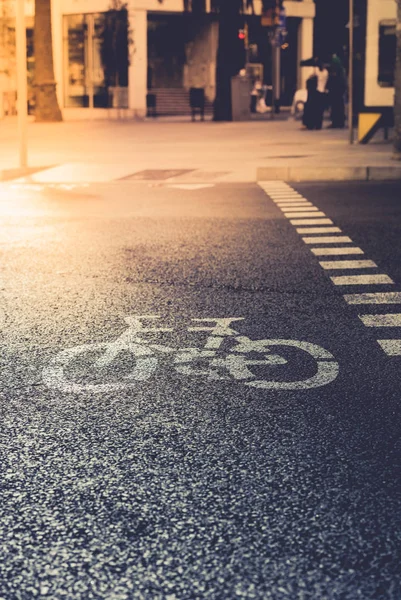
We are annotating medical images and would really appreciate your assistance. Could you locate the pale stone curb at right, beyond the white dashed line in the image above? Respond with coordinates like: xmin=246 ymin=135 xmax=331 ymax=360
xmin=256 ymin=166 xmax=401 ymax=181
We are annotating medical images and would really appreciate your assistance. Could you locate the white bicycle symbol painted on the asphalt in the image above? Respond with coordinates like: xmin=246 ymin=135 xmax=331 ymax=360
xmin=43 ymin=315 xmax=339 ymax=393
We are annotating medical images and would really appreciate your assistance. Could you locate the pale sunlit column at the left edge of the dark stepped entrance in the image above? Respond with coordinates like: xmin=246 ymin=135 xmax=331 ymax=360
xmin=128 ymin=8 xmax=148 ymax=119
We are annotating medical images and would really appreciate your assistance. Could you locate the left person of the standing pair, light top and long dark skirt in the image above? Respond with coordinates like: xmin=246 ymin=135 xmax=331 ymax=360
xmin=302 ymin=58 xmax=329 ymax=129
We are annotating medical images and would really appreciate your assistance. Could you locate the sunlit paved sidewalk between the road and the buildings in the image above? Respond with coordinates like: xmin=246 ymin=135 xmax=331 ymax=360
xmin=0 ymin=118 xmax=401 ymax=183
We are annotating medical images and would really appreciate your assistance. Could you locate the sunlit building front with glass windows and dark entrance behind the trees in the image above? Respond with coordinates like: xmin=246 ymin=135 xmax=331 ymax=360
xmin=0 ymin=0 xmax=315 ymax=118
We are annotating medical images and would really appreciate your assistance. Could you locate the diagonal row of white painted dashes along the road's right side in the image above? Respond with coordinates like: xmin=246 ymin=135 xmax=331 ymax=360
xmin=258 ymin=181 xmax=401 ymax=357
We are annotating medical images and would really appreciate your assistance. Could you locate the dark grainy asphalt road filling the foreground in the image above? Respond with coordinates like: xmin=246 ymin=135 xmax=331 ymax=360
xmin=0 ymin=182 xmax=401 ymax=600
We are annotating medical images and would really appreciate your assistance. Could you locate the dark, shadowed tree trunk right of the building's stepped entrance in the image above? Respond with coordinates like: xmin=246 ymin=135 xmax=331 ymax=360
xmin=213 ymin=0 xmax=240 ymax=121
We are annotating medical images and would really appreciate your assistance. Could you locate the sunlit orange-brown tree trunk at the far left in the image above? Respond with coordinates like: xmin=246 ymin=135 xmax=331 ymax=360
xmin=34 ymin=0 xmax=62 ymax=121
